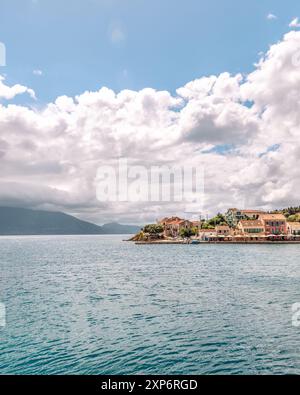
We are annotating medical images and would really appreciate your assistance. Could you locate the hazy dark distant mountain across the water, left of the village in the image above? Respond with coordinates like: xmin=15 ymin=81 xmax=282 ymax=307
xmin=0 ymin=207 xmax=139 ymax=235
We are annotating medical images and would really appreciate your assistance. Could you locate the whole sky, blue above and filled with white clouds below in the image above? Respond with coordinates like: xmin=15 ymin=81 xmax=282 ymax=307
xmin=0 ymin=0 xmax=300 ymax=224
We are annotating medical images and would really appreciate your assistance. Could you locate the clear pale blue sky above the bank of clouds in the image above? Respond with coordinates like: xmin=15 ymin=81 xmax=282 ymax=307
xmin=0 ymin=0 xmax=300 ymax=102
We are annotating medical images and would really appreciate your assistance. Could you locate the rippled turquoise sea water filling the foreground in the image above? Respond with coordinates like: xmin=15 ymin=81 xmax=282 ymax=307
xmin=0 ymin=236 xmax=300 ymax=374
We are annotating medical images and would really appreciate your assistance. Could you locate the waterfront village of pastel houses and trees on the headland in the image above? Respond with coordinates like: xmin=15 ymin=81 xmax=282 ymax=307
xmin=132 ymin=208 xmax=300 ymax=244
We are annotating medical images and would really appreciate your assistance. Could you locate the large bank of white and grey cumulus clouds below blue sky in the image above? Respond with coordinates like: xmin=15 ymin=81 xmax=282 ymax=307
xmin=0 ymin=31 xmax=300 ymax=223
